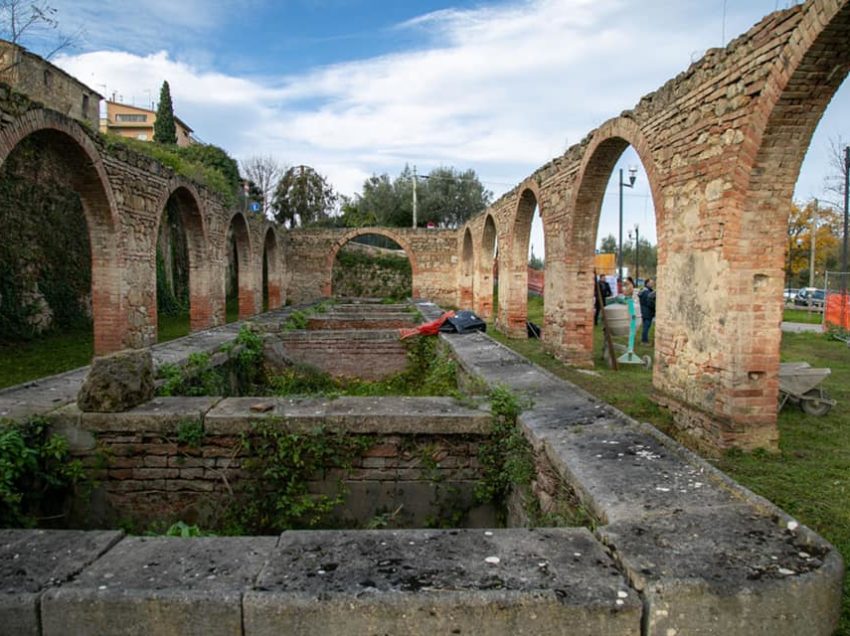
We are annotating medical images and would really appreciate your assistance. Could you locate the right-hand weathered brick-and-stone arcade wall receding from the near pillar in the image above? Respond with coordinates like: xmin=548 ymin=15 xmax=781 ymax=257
xmin=459 ymin=0 xmax=850 ymax=447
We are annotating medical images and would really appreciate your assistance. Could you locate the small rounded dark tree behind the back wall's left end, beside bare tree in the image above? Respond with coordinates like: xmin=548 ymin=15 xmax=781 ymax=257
xmin=272 ymin=166 xmax=337 ymax=227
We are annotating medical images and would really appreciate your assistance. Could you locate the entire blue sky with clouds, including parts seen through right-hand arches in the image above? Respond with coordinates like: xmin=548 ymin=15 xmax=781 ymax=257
xmin=16 ymin=0 xmax=850 ymax=254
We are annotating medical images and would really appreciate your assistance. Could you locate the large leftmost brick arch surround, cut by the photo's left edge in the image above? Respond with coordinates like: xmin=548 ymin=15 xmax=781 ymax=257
xmin=0 ymin=110 xmax=124 ymax=355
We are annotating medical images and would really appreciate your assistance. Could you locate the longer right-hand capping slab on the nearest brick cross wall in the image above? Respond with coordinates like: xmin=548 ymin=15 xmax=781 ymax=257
xmin=204 ymin=397 xmax=490 ymax=435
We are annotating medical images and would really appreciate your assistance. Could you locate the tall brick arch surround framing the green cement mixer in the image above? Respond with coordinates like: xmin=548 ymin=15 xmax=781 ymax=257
xmin=564 ymin=117 xmax=665 ymax=364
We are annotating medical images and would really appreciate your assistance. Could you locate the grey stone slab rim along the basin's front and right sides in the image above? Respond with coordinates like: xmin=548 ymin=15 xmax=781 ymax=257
xmin=0 ymin=303 xmax=843 ymax=636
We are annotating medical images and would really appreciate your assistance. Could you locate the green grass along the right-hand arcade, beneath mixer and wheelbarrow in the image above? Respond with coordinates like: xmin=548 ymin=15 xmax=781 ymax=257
xmin=489 ymin=299 xmax=850 ymax=635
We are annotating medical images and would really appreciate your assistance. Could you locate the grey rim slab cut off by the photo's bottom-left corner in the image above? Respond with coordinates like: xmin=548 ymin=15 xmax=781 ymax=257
xmin=0 ymin=530 xmax=124 ymax=636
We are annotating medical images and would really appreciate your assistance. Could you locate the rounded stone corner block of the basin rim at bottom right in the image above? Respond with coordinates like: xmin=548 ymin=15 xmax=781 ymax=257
xmin=598 ymin=506 xmax=843 ymax=636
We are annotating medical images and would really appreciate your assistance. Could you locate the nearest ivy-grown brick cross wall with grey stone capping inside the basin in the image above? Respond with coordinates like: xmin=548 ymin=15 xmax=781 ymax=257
xmin=52 ymin=397 xmax=495 ymax=528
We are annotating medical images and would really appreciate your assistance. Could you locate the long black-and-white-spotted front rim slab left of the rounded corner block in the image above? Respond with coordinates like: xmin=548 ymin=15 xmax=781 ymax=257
xmin=244 ymin=529 xmax=641 ymax=636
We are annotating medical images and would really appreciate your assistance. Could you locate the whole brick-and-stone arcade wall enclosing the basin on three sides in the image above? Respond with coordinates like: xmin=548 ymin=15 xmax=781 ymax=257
xmin=0 ymin=0 xmax=850 ymax=447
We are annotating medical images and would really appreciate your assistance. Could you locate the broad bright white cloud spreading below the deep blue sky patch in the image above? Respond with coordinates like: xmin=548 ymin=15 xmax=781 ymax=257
xmin=57 ymin=0 xmax=840 ymax=241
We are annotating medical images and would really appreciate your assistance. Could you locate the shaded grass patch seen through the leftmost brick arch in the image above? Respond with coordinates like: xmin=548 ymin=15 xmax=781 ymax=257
xmin=0 ymin=327 xmax=94 ymax=388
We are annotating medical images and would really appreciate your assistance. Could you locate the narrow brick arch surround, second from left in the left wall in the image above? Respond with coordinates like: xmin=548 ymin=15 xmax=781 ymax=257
xmin=152 ymin=179 xmax=213 ymax=331
